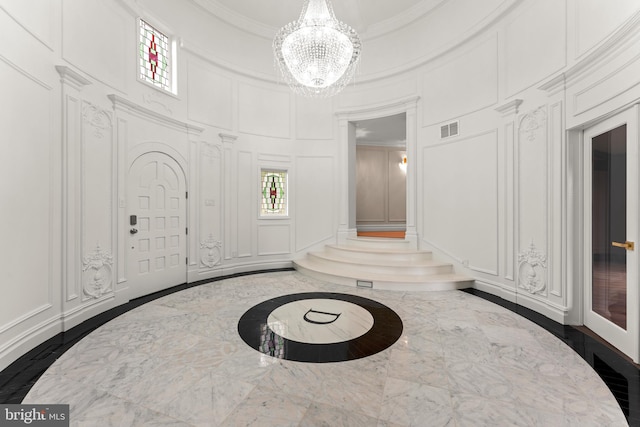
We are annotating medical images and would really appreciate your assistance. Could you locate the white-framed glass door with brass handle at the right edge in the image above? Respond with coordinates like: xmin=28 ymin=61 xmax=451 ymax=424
xmin=584 ymin=108 xmax=640 ymax=363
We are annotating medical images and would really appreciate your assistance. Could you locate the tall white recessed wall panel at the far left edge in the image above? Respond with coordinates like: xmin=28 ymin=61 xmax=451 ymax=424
xmin=0 ymin=59 xmax=53 ymax=330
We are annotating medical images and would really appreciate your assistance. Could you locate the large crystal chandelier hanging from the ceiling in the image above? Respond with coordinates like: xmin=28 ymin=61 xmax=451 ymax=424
xmin=273 ymin=0 xmax=361 ymax=97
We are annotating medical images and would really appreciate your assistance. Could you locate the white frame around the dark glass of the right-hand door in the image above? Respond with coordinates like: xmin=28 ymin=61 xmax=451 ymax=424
xmin=569 ymin=105 xmax=640 ymax=363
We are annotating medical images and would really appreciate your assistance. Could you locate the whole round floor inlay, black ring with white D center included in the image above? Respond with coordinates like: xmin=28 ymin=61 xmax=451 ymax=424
xmin=238 ymin=292 xmax=402 ymax=363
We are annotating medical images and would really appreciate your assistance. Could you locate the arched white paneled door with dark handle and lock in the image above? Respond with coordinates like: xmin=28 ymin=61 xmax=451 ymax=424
xmin=127 ymin=152 xmax=187 ymax=298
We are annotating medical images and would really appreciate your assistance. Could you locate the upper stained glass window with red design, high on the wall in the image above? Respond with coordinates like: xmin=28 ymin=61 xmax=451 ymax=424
xmin=140 ymin=19 xmax=172 ymax=92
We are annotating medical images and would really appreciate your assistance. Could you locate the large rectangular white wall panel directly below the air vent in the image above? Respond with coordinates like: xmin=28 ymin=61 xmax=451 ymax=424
xmin=422 ymin=131 xmax=498 ymax=274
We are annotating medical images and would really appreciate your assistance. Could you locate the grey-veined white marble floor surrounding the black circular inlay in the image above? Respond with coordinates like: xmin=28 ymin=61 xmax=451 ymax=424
xmin=23 ymin=271 xmax=627 ymax=427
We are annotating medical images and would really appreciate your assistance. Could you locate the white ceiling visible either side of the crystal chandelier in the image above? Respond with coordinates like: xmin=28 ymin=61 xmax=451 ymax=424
xmin=193 ymin=0 xmax=450 ymax=36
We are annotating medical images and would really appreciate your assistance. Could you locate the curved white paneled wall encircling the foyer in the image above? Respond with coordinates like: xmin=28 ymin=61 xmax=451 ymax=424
xmin=0 ymin=0 xmax=640 ymax=369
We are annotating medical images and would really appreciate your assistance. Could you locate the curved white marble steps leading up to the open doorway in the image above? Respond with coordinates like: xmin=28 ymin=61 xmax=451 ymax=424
xmin=294 ymin=237 xmax=473 ymax=291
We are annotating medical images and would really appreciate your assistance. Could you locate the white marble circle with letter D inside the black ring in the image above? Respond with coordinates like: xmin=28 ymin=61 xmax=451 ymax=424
xmin=267 ymin=298 xmax=374 ymax=344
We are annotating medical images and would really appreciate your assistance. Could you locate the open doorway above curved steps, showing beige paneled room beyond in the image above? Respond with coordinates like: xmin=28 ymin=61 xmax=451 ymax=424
xmin=352 ymin=113 xmax=408 ymax=239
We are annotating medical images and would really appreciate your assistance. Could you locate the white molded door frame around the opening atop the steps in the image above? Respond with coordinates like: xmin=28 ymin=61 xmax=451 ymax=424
xmin=336 ymin=96 xmax=420 ymax=248
